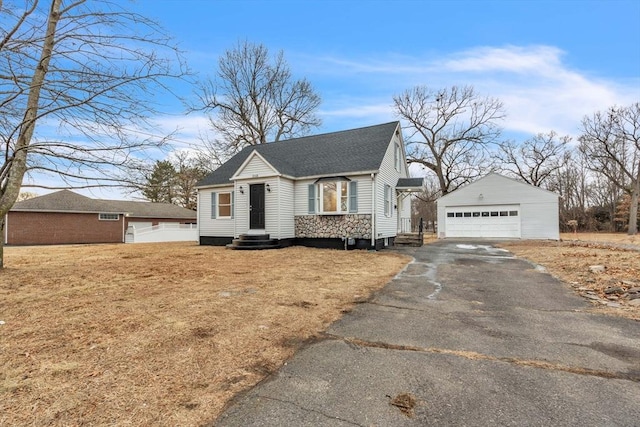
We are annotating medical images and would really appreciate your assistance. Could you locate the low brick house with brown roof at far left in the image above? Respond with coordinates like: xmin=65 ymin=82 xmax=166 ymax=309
xmin=4 ymin=190 xmax=197 ymax=245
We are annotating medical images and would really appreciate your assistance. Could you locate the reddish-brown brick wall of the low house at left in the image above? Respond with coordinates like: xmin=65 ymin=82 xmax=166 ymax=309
xmin=5 ymin=212 xmax=123 ymax=245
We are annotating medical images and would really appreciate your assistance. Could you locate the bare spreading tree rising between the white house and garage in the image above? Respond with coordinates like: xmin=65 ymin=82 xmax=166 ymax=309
xmin=393 ymin=86 xmax=505 ymax=195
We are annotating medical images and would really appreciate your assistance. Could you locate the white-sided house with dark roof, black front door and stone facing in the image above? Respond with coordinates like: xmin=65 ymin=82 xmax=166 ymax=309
xmin=198 ymin=122 xmax=422 ymax=249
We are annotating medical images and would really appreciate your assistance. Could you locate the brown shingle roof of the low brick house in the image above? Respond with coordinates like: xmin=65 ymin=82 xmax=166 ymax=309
xmin=11 ymin=190 xmax=196 ymax=219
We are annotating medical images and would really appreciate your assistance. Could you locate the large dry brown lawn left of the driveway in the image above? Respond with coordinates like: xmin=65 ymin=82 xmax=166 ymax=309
xmin=0 ymin=243 xmax=408 ymax=426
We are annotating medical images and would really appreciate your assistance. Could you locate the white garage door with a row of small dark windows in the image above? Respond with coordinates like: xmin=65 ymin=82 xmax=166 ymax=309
xmin=445 ymin=205 xmax=520 ymax=238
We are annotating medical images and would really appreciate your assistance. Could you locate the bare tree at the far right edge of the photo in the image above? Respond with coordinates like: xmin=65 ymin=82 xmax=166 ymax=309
xmin=579 ymin=103 xmax=640 ymax=235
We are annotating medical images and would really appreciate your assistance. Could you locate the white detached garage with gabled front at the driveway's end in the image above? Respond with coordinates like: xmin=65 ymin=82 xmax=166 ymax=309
xmin=437 ymin=173 xmax=560 ymax=240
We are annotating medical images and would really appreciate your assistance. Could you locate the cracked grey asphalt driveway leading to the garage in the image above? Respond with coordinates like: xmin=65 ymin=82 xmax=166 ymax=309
xmin=215 ymin=241 xmax=640 ymax=426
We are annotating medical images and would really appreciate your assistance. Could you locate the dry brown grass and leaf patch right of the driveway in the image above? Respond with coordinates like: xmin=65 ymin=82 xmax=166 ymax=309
xmin=500 ymin=233 xmax=640 ymax=320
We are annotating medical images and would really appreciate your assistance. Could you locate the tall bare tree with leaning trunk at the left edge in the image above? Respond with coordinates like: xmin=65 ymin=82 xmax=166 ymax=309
xmin=0 ymin=0 xmax=185 ymax=268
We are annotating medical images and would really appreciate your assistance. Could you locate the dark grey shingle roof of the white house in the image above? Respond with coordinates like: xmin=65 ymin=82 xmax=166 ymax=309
xmin=197 ymin=121 xmax=399 ymax=187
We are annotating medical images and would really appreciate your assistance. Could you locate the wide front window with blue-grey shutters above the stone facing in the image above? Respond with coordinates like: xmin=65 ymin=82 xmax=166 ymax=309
xmin=308 ymin=181 xmax=358 ymax=215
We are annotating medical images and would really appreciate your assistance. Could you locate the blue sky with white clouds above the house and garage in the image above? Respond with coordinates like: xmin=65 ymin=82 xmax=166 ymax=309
xmin=17 ymin=0 xmax=640 ymax=198
